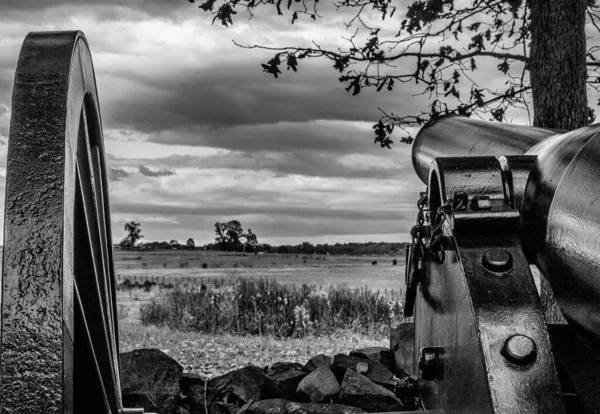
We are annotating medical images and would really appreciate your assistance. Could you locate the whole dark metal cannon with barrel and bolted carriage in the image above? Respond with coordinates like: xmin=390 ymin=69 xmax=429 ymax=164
xmin=405 ymin=115 xmax=600 ymax=413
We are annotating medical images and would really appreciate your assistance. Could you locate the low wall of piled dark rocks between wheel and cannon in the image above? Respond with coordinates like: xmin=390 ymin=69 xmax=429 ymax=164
xmin=121 ymin=325 xmax=419 ymax=414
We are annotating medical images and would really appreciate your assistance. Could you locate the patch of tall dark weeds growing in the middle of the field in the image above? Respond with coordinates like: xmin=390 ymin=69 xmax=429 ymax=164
xmin=140 ymin=278 xmax=402 ymax=337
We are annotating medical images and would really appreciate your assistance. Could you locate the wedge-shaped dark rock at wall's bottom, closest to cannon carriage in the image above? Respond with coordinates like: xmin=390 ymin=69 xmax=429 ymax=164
xmin=339 ymin=369 xmax=402 ymax=413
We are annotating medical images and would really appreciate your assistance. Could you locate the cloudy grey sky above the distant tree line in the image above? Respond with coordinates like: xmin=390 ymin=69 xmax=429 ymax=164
xmin=0 ymin=0 xmax=528 ymax=244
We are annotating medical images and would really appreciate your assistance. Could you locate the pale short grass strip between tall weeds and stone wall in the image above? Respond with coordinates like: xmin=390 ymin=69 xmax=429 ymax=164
xmin=119 ymin=320 xmax=389 ymax=378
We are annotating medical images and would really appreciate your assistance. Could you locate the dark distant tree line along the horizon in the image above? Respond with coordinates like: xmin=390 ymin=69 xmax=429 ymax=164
xmin=118 ymin=220 xmax=407 ymax=255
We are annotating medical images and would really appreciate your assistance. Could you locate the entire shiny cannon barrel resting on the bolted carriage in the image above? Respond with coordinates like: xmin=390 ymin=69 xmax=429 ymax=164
xmin=413 ymin=116 xmax=600 ymax=338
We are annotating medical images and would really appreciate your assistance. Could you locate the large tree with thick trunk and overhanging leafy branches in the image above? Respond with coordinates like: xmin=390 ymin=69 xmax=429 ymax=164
xmin=189 ymin=0 xmax=600 ymax=141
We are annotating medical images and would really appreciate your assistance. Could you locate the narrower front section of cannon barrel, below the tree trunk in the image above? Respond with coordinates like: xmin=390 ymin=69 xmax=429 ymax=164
xmin=412 ymin=115 xmax=559 ymax=184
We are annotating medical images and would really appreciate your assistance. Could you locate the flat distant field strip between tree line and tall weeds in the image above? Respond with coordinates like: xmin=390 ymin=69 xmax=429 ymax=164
xmin=114 ymin=250 xmax=404 ymax=291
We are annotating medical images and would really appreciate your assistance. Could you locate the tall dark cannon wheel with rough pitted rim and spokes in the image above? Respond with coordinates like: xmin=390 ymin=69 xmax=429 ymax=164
xmin=0 ymin=31 xmax=123 ymax=413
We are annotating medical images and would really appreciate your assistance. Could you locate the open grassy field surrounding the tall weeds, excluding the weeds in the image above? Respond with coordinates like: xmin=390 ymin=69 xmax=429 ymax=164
xmin=114 ymin=250 xmax=404 ymax=377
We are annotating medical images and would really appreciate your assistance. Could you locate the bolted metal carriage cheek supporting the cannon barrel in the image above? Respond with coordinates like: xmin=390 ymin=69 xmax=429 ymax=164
xmin=415 ymin=157 xmax=565 ymax=413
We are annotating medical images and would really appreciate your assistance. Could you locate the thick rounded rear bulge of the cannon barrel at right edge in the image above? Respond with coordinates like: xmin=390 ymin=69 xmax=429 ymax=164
xmin=538 ymin=134 xmax=600 ymax=339
